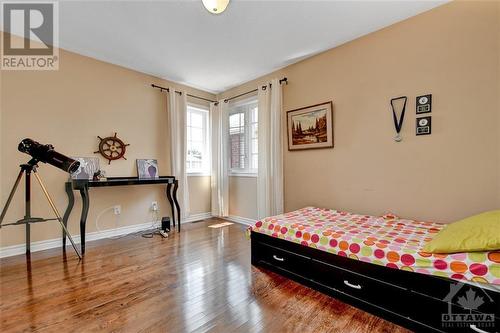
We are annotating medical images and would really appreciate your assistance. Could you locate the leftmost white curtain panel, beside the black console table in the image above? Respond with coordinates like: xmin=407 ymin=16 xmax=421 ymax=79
xmin=168 ymin=87 xmax=189 ymax=219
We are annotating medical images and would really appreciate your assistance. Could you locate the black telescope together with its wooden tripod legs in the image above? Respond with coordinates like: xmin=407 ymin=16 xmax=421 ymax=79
xmin=0 ymin=138 xmax=82 ymax=259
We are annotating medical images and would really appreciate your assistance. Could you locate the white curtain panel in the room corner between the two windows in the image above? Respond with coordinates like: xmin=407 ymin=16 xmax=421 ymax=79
xmin=210 ymin=100 xmax=229 ymax=217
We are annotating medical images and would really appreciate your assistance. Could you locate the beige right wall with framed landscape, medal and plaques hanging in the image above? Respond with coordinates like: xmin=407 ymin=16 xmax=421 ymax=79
xmin=217 ymin=1 xmax=500 ymax=222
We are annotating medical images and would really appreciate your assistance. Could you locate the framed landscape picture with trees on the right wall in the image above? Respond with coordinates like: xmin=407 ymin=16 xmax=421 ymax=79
xmin=286 ymin=101 xmax=333 ymax=150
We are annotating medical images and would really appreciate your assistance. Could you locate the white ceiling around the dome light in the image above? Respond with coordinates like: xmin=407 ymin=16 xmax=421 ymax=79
xmin=59 ymin=0 xmax=444 ymax=93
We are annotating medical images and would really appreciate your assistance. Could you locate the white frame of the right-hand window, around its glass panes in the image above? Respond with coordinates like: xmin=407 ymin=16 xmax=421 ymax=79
xmin=228 ymin=96 xmax=258 ymax=177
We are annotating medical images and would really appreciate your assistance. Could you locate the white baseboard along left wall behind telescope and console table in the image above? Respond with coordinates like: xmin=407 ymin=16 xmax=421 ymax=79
xmin=0 ymin=222 xmax=159 ymax=258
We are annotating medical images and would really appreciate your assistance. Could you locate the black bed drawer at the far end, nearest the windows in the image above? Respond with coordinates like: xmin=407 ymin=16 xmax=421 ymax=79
xmin=252 ymin=242 xmax=311 ymax=276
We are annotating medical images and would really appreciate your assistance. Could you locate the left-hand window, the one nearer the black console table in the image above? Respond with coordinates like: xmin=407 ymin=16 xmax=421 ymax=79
xmin=186 ymin=105 xmax=210 ymax=175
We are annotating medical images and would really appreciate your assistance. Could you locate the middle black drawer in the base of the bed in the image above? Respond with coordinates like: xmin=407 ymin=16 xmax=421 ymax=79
xmin=312 ymin=259 xmax=408 ymax=316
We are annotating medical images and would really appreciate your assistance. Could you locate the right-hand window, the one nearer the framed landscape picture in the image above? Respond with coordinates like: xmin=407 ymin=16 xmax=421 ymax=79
xmin=229 ymin=99 xmax=259 ymax=174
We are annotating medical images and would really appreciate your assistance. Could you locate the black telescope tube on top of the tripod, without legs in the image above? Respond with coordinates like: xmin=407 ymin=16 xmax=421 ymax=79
xmin=17 ymin=138 xmax=80 ymax=173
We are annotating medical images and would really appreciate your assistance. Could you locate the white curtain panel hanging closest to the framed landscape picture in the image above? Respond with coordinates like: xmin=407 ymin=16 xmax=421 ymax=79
xmin=257 ymin=79 xmax=284 ymax=219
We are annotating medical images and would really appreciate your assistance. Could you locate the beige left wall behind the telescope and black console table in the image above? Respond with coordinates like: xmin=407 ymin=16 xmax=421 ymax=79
xmin=0 ymin=40 xmax=214 ymax=246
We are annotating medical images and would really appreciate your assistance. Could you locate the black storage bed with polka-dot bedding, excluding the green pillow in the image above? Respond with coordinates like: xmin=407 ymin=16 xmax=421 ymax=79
xmin=250 ymin=207 xmax=500 ymax=332
